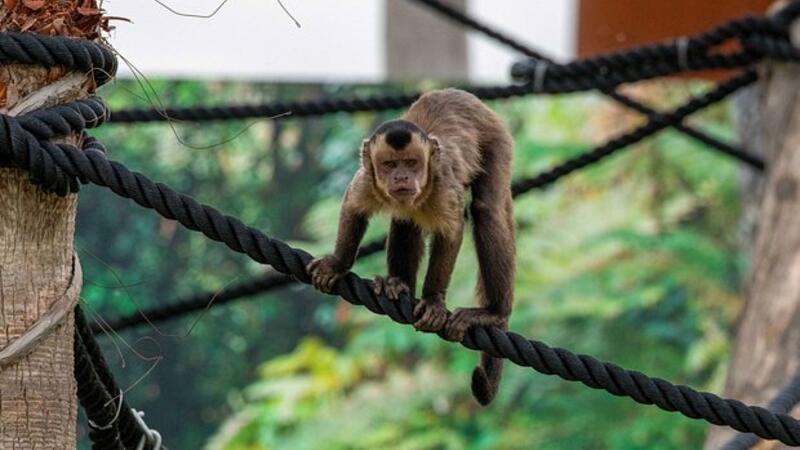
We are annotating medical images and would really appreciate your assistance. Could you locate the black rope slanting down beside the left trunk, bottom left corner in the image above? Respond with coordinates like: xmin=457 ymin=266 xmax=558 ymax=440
xmin=75 ymin=305 xmax=153 ymax=450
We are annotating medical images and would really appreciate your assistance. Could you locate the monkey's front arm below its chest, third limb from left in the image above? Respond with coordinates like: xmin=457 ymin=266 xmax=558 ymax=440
xmin=414 ymin=220 xmax=464 ymax=331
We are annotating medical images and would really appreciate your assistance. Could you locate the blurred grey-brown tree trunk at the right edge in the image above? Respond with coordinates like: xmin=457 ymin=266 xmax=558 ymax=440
xmin=706 ymin=5 xmax=800 ymax=449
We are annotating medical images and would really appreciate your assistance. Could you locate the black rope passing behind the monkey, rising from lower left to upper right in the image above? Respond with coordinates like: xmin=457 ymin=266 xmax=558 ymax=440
xmin=100 ymin=72 xmax=756 ymax=331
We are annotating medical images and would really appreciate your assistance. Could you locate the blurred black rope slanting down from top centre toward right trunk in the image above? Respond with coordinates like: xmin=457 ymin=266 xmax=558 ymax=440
xmin=411 ymin=0 xmax=768 ymax=170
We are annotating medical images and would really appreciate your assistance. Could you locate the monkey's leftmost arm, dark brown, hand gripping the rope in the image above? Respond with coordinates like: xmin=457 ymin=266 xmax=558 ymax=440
xmin=306 ymin=192 xmax=369 ymax=293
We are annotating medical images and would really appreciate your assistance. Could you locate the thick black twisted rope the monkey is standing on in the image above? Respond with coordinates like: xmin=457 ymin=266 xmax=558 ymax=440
xmin=9 ymin=72 xmax=800 ymax=445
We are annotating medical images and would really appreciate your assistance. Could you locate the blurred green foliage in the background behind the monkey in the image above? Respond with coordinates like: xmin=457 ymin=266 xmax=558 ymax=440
xmin=78 ymin=81 xmax=742 ymax=450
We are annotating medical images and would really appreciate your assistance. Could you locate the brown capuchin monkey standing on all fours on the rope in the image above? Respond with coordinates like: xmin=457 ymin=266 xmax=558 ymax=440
xmin=307 ymin=89 xmax=515 ymax=405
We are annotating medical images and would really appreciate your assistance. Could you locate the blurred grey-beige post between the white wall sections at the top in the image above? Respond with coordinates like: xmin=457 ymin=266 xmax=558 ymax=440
xmin=385 ymin=0 xmax=468 ymax=81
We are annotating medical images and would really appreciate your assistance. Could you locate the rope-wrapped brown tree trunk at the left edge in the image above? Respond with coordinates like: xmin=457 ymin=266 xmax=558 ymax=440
xmin=0 ymin=0 xmax=103 ymax=449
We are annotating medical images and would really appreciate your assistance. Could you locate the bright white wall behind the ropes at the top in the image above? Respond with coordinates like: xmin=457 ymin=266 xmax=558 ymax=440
xmin=104 ymin=0 xmax=575 ymax=82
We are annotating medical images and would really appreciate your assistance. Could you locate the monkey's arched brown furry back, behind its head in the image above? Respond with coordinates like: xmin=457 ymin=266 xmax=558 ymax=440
xmin=404 ymin=88 xmax=513 ymax=185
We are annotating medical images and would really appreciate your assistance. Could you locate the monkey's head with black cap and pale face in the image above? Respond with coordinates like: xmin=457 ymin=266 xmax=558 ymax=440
xmin=361 ymin=120 xmax=439 ymax=205
